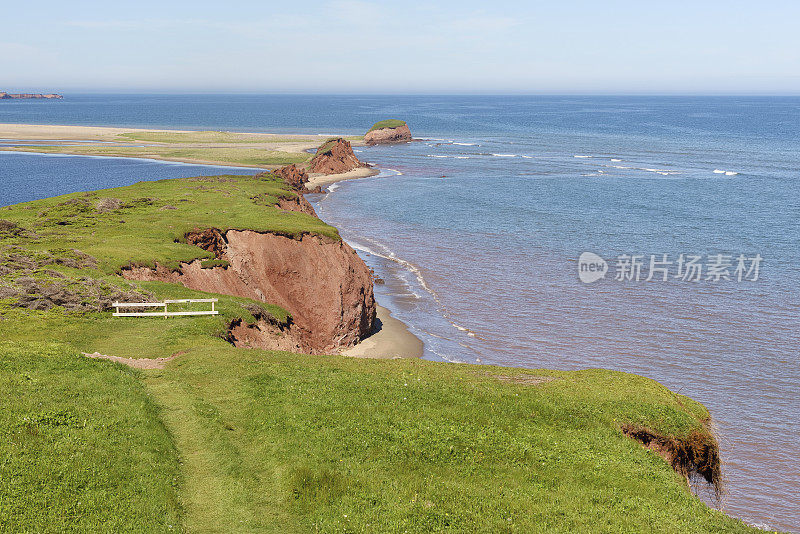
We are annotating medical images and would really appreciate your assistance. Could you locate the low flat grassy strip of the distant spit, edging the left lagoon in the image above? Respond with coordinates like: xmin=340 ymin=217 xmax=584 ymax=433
xmin=2 ymin=145 xmax=311 ymax=167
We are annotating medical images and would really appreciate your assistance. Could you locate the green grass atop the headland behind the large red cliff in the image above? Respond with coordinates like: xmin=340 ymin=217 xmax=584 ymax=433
xmin=0 ymin=175 xmax=339 ymax=274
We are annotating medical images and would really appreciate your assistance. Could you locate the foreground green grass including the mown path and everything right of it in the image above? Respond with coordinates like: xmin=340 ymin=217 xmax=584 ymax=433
xmin=147 ymin=347 xmax=750 ymax=533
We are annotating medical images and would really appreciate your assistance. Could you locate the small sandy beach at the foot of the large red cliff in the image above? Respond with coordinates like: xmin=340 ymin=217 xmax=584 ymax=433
xmin=342 ymin=306 xmax=422 ymax=359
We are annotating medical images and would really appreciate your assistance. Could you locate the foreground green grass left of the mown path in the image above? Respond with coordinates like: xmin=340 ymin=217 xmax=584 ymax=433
xmin=0 ymin=342 xmax=183 ymax=532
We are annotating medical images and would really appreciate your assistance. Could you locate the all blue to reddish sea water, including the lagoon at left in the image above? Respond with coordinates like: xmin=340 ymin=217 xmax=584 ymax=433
xmin=0 ymin=95 xmax=800 ymax=530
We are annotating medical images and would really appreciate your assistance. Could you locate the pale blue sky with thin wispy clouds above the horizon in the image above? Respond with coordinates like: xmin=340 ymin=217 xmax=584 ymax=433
xmin=0 ymin=0 xmax=800 ymax=94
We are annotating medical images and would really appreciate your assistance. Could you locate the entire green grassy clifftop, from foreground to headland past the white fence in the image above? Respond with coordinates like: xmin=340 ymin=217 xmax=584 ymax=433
xmin=0 ymin=176 xmax=752 ymax=533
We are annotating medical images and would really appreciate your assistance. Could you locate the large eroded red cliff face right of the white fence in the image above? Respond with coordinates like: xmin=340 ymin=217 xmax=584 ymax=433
xmin=122 ymin=229 xmax=376 ymax=353
